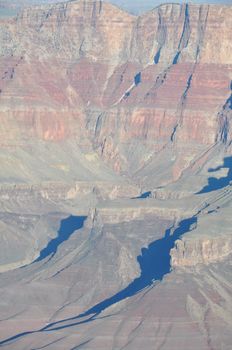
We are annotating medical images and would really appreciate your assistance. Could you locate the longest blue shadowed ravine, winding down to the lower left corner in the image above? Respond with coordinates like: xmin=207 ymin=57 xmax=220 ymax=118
xmin=0 ymin=215 xmax=197 ymax=345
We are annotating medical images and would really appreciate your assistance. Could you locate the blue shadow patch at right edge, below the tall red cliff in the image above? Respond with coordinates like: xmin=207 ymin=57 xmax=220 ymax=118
xmin=196 ymin=157 xmax=232 ymax=194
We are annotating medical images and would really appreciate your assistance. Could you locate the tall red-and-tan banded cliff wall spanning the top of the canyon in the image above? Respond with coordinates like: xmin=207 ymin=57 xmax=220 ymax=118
xmin=0 ymin=1 xmax=232 ymax=185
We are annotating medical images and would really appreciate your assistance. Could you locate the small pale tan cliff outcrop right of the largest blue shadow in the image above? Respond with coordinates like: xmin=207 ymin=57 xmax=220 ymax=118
xmin=170 ymin=204 xmax=232 ymax=268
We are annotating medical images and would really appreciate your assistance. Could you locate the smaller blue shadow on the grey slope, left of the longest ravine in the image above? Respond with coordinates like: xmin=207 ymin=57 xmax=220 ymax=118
xmin=34 ymin=215 xmax=87 ymax=262
